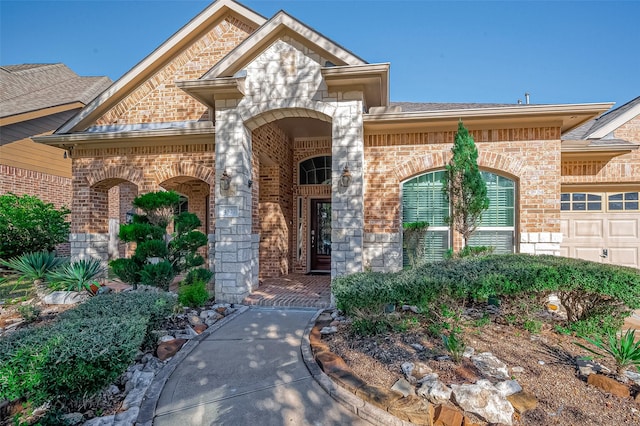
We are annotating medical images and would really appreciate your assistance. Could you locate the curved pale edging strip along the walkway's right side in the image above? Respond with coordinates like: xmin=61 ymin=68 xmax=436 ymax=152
xmin=300 ymin=309 xmax=414 ymax=426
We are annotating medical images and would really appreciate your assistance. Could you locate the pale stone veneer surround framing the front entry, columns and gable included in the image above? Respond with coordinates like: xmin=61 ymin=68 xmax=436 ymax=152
xmin=215 ymin=36 xmax=363 ymax=302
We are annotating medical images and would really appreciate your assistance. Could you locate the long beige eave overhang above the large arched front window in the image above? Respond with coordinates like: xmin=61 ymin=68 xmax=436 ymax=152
xmin=363 ymin=103 xmax=613 ymax=133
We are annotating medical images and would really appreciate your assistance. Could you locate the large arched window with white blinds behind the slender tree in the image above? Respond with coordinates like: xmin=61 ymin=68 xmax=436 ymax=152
xmin=402 ymin=171 xmax=515 ymax=261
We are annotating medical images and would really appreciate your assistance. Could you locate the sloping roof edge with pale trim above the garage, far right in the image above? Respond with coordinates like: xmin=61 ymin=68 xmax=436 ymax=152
xmin=562 ymin=96 xmax=640 ymax=140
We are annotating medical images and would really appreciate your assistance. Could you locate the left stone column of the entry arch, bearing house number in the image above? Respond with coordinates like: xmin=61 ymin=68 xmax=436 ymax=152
xmin=214 ymin=105 xmax=258 ymax=303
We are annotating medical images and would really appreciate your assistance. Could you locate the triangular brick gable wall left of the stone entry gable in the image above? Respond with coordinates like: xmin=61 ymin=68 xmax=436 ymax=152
xmin=96 ymin=15 xmax=255 ymax=125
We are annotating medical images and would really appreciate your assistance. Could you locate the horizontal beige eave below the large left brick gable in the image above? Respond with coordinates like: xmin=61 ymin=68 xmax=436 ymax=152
xmin=33 ymin=121 xmax=215 ymax=149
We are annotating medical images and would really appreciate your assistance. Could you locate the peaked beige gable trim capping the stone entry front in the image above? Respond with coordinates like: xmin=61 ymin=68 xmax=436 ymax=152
xmin=200 ymin=10 xmax=367 ymax=80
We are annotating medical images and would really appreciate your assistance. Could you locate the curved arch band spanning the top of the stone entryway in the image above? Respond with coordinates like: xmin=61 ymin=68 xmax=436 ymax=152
xmin=242 ymin=99 xmax=336 ymax=130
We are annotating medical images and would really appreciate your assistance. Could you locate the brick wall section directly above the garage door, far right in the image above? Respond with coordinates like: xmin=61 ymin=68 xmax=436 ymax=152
xmin=562 ymin=116 xmax=640 ymax=184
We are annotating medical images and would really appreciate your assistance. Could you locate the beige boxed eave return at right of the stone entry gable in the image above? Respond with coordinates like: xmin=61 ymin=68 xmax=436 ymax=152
xmin=320 ymin=63 xmax=389 ymax=108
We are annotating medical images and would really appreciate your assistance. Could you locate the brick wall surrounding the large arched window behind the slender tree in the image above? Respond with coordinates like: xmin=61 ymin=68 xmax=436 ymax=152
xmin=365 ymin=128 xmax=560 ymax=251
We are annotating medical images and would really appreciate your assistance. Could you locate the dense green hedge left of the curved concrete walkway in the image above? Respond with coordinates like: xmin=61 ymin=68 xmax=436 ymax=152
xmin=0 ymin=293 xmax=175 ymax=404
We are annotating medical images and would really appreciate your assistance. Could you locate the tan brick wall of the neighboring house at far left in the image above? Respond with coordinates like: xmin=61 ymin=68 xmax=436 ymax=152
xmin=0 ymin=164 xmax=71 ymax=256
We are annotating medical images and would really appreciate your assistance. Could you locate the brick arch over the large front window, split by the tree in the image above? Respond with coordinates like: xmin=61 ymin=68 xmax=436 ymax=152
xmin=394 ymin=151 xmax=524 ymax=182
